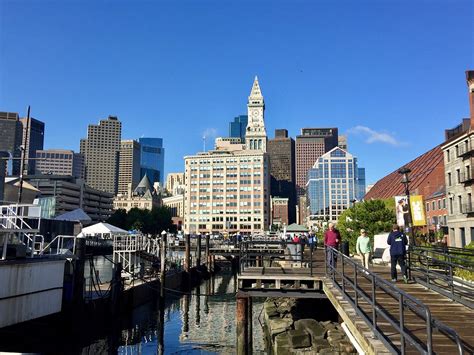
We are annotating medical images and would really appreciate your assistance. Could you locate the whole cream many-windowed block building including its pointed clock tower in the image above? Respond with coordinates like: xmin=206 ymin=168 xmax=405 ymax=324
xmin=184 ymin=78 xmax=270 ymax=234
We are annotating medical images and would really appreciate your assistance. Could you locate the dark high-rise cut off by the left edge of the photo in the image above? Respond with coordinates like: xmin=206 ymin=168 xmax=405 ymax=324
xmin=0 ymin=112 xmax=23 ymax=175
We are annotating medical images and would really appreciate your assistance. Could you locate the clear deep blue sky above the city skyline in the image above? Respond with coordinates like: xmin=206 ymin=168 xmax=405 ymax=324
xmin=0 ymin=0 xmax=474 ymax=183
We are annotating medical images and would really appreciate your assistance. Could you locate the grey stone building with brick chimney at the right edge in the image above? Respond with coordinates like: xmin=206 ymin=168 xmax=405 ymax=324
xmin=441 ymin=70 xmax=474 ymax=248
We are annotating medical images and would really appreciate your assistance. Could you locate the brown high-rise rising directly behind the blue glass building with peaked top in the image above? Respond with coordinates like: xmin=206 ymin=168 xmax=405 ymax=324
xmin=296 ymin=128 xmax=338 ymax=197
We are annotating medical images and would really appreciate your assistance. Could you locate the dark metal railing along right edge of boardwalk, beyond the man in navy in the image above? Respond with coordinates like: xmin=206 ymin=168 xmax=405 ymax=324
xmin=407 ymin=247 xmax=474 ymax=309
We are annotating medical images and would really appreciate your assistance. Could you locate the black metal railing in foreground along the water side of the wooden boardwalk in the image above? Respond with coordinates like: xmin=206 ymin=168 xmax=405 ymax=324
xmin=325 ymin=248 xmax=463 ymax=355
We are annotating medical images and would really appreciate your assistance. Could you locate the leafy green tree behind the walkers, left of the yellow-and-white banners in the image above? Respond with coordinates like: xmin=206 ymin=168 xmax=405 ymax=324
xmin=337 ymin=199 xmax=396 ymax=252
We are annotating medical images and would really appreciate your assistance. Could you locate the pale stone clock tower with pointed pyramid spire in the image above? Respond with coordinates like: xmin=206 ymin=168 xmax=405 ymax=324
xmin=245 ymin=77 xmax=267 ymax=152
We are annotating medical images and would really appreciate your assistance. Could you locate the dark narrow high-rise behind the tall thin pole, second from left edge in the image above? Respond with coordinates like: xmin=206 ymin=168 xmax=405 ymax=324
xmin=20 ymin=117 xmax=44 ymax=174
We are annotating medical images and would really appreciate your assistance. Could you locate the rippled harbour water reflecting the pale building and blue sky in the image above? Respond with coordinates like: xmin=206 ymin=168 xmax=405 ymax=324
xmin=118 ymin=271 xmax=266 ymax=354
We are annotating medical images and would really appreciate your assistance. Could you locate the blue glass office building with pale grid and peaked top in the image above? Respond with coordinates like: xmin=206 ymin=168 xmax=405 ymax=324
xmin=306 ymin=147 xmax=358 ymax=222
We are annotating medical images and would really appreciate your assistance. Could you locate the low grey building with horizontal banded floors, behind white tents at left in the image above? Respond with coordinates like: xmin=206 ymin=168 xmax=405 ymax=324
xmin=25 ymin=175 xmax=113 ymax=222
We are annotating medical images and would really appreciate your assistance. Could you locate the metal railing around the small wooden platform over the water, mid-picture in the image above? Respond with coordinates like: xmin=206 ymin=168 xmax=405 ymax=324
xmin=239 ymin=239 xmax=317 ymax=276
